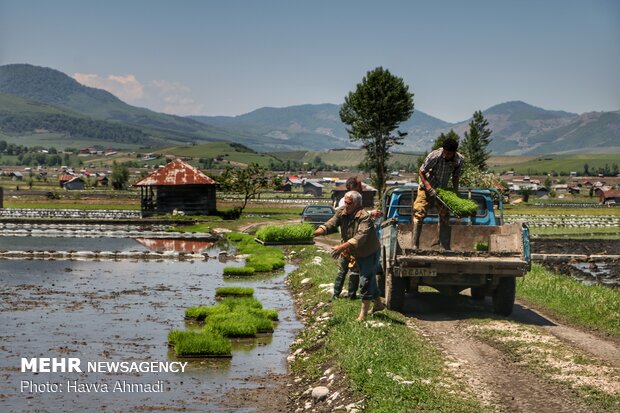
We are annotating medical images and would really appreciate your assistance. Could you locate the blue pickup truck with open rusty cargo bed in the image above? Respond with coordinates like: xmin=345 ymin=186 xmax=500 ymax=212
xmin=377 ymin=185 xmax=531 ymax=316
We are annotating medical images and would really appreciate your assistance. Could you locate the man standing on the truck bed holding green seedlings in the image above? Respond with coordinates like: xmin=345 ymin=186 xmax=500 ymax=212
xmin=412 ymin=138 xmax=465 ymax=249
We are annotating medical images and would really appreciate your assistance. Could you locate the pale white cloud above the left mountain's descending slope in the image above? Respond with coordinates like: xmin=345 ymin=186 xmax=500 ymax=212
xmin=73 ymin=73 xmax=204 ymax=115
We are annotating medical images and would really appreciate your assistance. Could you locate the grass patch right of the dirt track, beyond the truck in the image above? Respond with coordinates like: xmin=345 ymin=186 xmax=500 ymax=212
xmin=517 ymin=264 xmax=620 ymax=337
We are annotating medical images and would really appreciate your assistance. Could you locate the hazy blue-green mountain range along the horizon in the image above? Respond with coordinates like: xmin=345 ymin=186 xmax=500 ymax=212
xmin=0 ymin=64 xmax=620 ymax=155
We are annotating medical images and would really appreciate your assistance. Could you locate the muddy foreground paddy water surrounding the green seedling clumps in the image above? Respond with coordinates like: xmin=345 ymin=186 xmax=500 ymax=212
xmin=0 ymin=249 xmax=301 ymax=412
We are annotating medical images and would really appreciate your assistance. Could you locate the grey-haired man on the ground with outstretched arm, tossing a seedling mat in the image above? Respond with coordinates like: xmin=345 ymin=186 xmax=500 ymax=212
xmin=314 ymin=191 xmax=385 ymax=321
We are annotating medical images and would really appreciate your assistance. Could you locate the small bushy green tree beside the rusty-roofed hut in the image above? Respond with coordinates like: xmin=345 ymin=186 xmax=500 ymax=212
xmin=218 ymin=163 xmax=271 ymax=211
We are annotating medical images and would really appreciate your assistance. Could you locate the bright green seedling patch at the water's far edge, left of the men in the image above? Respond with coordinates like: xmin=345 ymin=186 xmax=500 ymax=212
xmin=224 ymin=232 xmax=285 ymax=276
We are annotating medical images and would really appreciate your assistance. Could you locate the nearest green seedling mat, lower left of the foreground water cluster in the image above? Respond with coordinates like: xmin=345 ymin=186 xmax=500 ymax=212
xmin=168 ymin=330 xmax=232 ymax=357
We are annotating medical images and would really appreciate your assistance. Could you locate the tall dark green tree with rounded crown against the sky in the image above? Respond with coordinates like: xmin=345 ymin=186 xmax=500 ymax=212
xmin=340 ymin=67 xmax=414 ymax=199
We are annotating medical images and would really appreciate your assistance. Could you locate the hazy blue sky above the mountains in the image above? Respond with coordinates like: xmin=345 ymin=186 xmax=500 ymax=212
xmin=0 ymin=0 xmax=620 ymax=122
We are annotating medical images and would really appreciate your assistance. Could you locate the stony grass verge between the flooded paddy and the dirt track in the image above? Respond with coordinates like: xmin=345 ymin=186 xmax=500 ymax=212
xmin=289 ymin=247 xmax=486 ymax=412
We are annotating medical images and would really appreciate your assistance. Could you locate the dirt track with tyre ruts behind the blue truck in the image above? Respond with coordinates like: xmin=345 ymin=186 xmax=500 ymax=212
xmin=404 ymin=293 xmax=620 ymax=412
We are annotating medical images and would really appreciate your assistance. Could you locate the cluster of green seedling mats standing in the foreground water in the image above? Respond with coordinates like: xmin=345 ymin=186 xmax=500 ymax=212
xmin=168 ymin=287 xmax=278 ymax=358
